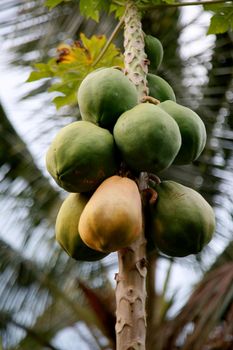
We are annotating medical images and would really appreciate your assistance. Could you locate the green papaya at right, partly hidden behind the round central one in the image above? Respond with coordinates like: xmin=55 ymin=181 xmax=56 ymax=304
xmin=158 ymin=101 xmax=206 ymax=165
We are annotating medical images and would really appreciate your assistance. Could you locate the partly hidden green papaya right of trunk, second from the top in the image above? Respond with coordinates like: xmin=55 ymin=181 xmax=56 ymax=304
xmin=147 ymin=74 xmax=176 ymax=102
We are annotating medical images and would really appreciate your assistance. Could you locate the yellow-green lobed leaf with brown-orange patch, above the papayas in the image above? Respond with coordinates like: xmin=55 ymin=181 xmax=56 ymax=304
xmin=27 ymin=34 xmax=123 ymax=109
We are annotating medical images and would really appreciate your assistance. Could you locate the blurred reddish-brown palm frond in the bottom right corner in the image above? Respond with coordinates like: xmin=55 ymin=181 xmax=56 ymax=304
xmin=163 ymin=262 xmax=233 ymax=350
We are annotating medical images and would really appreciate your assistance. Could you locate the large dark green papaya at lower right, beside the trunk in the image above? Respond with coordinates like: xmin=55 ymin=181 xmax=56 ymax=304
xmin=149 ymin=181 xmax=215 ymax=257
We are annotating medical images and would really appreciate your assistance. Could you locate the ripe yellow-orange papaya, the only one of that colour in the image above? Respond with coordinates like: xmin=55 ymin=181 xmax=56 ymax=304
xmin=78 ymin=175 xmax=142 ymax=253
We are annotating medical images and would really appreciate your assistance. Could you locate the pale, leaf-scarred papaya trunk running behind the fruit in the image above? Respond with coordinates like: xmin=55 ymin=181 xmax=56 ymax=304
xmin=116 ymin=0 xmax=148 ymax=350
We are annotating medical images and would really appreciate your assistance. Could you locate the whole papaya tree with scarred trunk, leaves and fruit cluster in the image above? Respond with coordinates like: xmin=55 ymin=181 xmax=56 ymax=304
xmin=1 ymin=1 xmax=231 ymax=349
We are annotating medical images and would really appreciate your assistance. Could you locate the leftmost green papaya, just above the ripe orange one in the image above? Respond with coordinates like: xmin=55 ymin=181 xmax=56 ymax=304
xmin=46 ymin=121 xmax=117 ymax=192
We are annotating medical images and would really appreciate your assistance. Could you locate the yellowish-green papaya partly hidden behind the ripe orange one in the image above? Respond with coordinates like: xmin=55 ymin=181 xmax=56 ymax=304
xmin=55 ymin=193 xmax=107 ymax=261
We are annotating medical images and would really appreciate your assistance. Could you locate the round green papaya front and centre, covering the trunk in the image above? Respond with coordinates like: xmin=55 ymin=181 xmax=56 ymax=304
xmin=113 ymin=103 xmax=181 ymax=173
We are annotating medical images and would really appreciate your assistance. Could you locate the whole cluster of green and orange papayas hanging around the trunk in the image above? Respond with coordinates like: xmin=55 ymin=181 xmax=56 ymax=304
xmin=46 ymin=36 xmax=215 ymax=261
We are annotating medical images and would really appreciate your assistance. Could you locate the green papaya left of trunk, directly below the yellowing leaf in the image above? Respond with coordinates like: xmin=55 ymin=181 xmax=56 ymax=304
xmin=78 ymin=68 xmax=138 ymax=130
